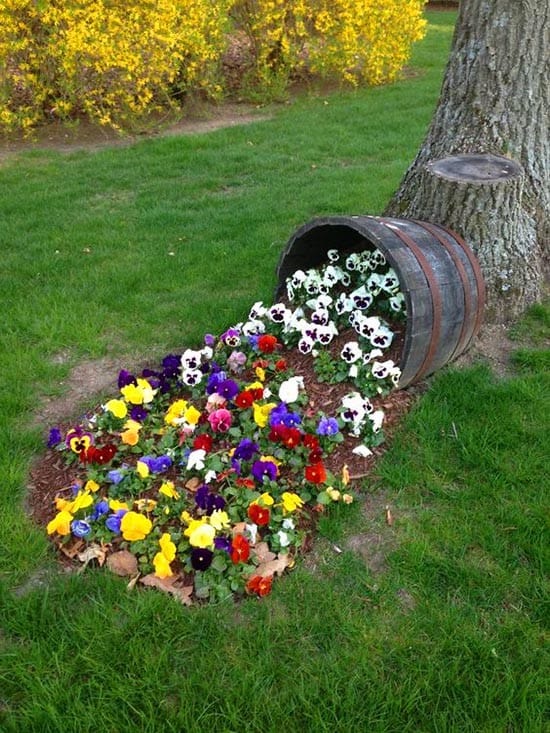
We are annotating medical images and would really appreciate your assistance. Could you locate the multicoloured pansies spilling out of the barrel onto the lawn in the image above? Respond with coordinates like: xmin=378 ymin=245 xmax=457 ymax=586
xmin=47 ymin=250 xmax=404 ymax=603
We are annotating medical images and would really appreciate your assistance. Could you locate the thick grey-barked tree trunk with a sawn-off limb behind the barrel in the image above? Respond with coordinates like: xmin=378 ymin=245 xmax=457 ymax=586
xmin=385 ymin=0 xmax=550 ymax=321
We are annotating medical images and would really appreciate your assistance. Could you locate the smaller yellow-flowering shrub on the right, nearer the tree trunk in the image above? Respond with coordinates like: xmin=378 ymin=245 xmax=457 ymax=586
xmin=232 ymin=0 xmax=426 ymax=96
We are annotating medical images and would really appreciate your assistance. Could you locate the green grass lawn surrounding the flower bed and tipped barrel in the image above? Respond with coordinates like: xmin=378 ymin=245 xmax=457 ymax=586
xmin=0 ymin=12 xmax=550 ymax=733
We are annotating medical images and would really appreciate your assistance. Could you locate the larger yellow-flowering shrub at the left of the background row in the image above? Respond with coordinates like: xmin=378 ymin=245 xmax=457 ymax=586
xmin=0 ymin=0 xmax=231 ymax=129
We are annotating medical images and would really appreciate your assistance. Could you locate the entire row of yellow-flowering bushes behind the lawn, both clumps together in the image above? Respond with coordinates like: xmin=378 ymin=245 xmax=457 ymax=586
xmin=0 ymin=0 xmax=425 ymax=130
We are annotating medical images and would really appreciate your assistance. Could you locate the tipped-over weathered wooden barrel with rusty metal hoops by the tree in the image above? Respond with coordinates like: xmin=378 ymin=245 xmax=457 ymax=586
xmin=276 ymin=216 xmax=485 ymax=388
